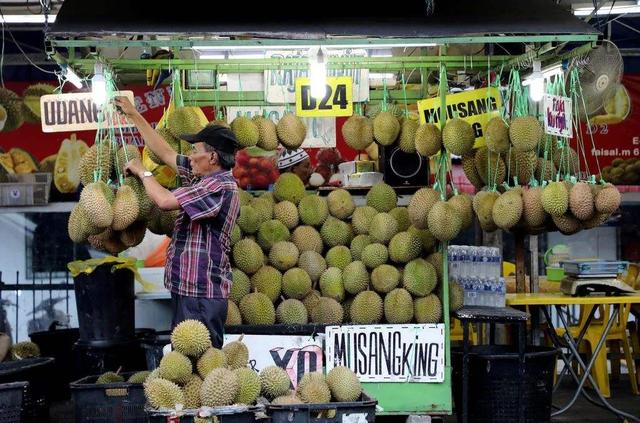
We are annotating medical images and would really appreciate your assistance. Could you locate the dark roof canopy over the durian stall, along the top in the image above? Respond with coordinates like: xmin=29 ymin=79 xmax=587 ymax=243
xmin=49 ymin=0 xmax=599 ymax=42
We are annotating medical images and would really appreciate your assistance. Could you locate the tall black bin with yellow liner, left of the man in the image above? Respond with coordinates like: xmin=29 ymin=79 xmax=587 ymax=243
xmin=74 ymin=264 xmax=135 ymax=347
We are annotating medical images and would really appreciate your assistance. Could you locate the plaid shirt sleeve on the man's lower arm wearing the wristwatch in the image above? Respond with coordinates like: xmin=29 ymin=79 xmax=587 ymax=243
xmin=173 ymin=179 xmax=225 ymax=220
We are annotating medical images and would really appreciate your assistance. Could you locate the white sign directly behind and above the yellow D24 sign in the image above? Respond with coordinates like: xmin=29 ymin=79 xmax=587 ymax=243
xmin=264 ymin=49 xmax=369 ymax=104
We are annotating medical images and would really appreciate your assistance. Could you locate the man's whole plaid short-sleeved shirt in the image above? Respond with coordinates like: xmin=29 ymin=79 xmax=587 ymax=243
xmin=164 ymin=155 xmax=240 ymax=298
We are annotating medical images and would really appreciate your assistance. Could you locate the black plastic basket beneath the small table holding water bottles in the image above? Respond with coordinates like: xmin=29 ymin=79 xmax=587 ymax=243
xmin=451 ymin=345 xmax=557 ymax=423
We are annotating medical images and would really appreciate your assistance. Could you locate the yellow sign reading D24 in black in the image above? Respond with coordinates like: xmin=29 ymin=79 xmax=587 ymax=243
xmin=296 ymin=76 xmax=353 ymax=117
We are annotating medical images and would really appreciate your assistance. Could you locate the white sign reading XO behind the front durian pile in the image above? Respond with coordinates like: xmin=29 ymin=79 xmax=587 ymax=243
xmin=224 ymin=335 xmax=324 ymax=388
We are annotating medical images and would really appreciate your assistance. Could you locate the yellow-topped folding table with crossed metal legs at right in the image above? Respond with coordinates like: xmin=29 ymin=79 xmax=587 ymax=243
xmin=506 ymin=292 xmax=640 ymax=422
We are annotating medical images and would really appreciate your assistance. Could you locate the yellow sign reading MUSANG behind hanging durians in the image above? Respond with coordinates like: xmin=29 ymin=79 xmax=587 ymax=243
xmin=418 ymin=88 xmax=502 ymax=147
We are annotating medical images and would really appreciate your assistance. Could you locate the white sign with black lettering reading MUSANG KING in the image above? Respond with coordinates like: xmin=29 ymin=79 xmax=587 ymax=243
xmin=325 ymin=324 xmax=445 ymax=383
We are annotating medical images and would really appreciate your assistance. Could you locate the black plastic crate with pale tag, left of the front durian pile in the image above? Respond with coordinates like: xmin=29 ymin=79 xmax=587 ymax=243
xmin=70 ymin=373 xmax=147 ymax=423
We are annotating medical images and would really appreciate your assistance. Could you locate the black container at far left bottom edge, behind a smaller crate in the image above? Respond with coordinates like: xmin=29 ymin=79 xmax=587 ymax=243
xmin=0 ymin=357 xmax=55 ymax=423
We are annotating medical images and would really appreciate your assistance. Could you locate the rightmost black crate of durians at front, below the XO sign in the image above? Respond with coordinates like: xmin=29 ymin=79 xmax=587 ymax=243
xmin=267 ymin=392 xmax=378 ymax=423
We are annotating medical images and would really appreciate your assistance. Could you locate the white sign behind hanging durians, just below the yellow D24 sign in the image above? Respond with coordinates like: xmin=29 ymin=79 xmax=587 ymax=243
xmin=227 ymin=106 xmax=336 ymax=148
